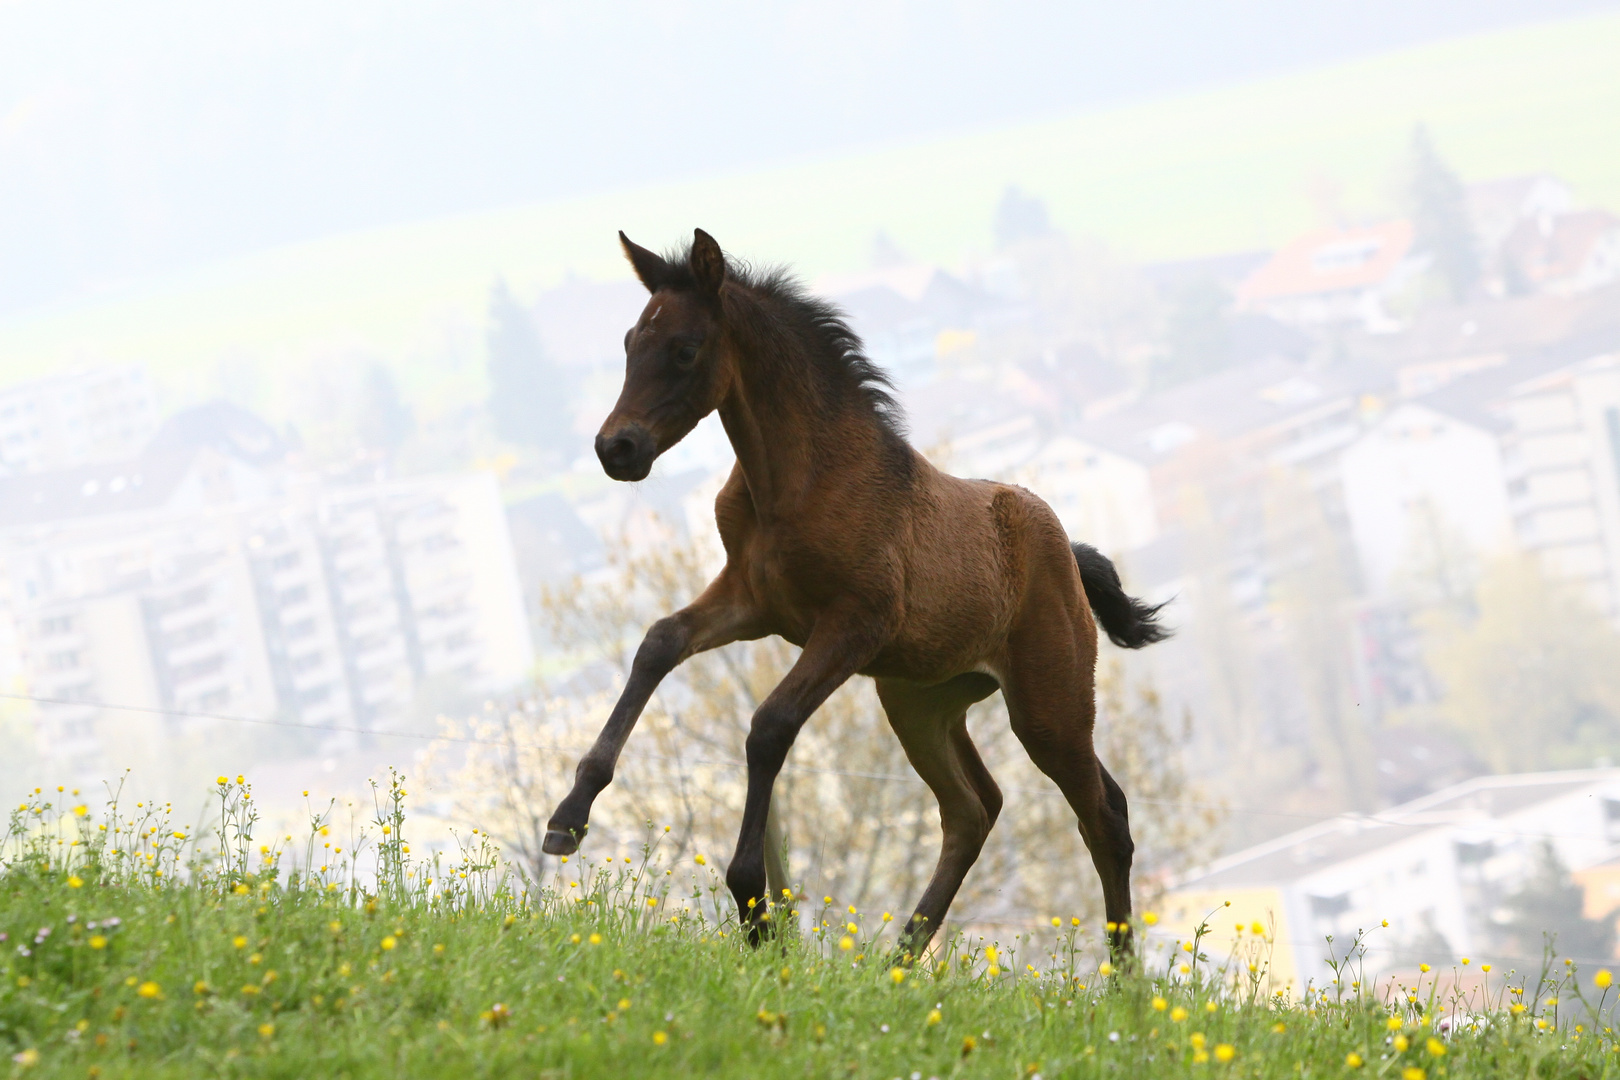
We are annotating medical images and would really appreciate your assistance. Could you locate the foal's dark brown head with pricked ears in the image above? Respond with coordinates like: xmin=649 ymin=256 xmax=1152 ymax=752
xmin=596 ymin=228 xmax=734 ymax=479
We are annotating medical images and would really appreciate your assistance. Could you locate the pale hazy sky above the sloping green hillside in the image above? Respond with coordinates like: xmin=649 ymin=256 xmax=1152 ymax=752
xmin=0 ymin=0 xmax=1620 ymax=316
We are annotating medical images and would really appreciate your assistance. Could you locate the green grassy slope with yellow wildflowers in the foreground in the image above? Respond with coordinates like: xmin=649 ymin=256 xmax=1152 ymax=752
xmin=0 ymin=777 xmax=1617 ymax=1078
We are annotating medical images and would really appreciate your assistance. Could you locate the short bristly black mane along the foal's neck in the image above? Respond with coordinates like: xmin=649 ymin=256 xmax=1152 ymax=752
xmin=664 ymin=246 xmax=910 ymax=450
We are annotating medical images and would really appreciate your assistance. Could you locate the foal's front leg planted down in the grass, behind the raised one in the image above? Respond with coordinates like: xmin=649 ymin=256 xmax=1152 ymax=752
xmin=726 ymin=617 xmax=878 ymax=944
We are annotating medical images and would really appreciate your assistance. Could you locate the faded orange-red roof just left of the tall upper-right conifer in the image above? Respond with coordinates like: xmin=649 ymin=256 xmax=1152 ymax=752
xmin=1238 ymin=220 xmax=1413 ymax=308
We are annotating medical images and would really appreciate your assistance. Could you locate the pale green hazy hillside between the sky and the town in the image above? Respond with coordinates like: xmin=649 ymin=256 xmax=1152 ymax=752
xmin=0 ymin=16 xmax=1620 ymax=417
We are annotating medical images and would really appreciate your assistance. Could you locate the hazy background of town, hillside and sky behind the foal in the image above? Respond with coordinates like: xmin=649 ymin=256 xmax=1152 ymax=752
xmin=0 ymin=3 xmax=1620 ymax=978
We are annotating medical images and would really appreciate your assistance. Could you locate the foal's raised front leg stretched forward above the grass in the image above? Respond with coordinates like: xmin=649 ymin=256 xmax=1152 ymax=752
xmin=541 ymin=567 xmax=760 ymax=855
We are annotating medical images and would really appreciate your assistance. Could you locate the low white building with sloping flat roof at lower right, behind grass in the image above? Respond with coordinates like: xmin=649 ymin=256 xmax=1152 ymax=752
xmin=1155 ymin=769 xmax=1620 ymax=993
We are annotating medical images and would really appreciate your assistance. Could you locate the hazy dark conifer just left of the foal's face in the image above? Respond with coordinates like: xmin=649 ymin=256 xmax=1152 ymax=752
xmin=488 ymin=280 xmax=573 ymax=452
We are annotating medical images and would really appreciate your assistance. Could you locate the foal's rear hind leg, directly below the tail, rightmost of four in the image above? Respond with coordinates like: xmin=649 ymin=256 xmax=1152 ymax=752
xmin=1001 ymin=621 xmax=1136 ymax=952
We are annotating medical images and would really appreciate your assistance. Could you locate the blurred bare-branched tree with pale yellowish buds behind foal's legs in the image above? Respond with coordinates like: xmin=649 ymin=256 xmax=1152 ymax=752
xmin=433 ymin=524 xmax=1217 ymax=926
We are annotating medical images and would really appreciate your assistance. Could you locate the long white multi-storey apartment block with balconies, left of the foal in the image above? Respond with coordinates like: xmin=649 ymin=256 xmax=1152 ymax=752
xmin=0 ymin=406 xmax=531 ymax=776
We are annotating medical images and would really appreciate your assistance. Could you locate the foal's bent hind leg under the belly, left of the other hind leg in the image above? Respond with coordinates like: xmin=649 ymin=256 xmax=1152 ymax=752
xmin=878 ymin=674 xmax=1001 ymax=957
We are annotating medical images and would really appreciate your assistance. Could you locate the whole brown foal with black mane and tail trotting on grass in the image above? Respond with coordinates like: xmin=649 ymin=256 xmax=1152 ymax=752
xmin=544 ymin=230 xmax=1165 ymax=955
